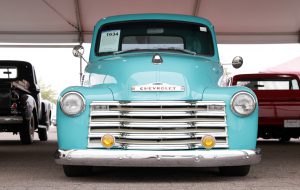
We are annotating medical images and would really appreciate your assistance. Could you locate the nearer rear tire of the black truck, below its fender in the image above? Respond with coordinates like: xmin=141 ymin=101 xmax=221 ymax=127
xmin=20 ymin=114 xmax=35 ymax=144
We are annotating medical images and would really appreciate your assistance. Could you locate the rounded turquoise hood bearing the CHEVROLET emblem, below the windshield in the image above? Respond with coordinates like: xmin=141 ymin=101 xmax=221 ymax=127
xmin=86 ymin=52 xmax=223 ymax=100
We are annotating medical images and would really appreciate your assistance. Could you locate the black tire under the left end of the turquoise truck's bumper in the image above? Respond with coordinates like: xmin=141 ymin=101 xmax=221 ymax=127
xmin=63 ymin=165 xmax=93 ymax=177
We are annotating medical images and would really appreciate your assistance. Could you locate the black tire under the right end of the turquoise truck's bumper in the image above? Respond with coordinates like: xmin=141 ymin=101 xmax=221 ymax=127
xmin=219 ymin=165 xmax=250 ymax=176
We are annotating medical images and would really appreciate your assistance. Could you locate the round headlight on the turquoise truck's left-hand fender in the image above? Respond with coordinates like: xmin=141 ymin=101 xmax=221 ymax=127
xmin=60 ymin=92 xmax=85 ymax=116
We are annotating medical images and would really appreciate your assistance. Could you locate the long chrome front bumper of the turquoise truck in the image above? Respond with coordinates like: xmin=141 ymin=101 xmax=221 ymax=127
xmin=55 ymin=149 xmax=261 ymax=167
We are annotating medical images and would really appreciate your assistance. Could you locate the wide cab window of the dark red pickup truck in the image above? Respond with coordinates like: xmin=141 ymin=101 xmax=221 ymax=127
xmin=237 ymin=78 xmax=299 ymax=90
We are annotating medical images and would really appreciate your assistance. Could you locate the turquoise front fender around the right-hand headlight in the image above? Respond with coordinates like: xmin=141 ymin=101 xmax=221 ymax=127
xmin=203 ymin=87 xmax=258 ymax=149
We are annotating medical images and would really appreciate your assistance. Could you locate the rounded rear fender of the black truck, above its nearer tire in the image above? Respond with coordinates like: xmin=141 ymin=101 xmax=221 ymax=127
xmin=20 ymin=94 xmax=37 ymax=127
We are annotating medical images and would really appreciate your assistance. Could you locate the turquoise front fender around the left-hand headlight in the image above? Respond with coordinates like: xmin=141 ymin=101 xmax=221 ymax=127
xmin=56 ymin=86 xmax=113 ymax=150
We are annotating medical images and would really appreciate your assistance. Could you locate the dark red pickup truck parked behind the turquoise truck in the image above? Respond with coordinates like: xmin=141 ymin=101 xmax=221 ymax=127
xmin=231 ymin=73 xmax=300 ymax=141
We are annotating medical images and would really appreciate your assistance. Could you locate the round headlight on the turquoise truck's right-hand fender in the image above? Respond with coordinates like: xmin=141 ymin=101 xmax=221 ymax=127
xmin=231 ymin=92 xmax=256 ymax=116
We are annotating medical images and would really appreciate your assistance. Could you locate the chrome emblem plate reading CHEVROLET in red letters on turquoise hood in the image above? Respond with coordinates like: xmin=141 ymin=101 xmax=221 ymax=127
xmin=131 ymin=82 xmax=185 ymax=92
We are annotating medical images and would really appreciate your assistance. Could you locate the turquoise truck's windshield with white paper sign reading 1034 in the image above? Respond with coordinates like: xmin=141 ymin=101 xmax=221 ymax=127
xmin=96 ymin=20 xmax=214 ymax=56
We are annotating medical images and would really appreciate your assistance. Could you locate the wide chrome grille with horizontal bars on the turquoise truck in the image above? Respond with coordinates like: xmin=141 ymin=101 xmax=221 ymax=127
xmin=88 ymin=101 xmax=228 ymax=150
